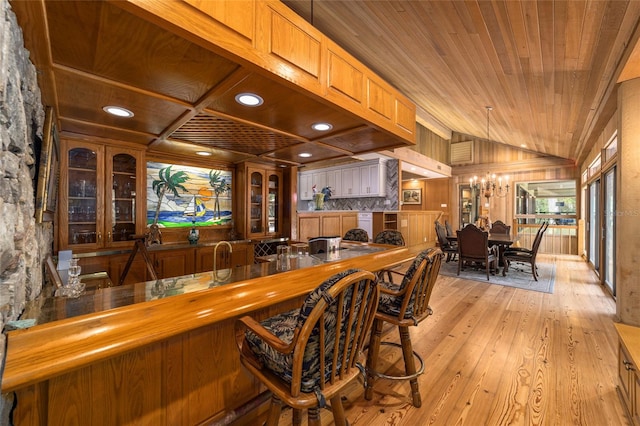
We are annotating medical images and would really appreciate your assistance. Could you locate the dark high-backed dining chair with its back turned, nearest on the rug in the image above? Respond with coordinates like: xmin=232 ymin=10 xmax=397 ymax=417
xmin=456 ymin=224 xmax=498 ymax=280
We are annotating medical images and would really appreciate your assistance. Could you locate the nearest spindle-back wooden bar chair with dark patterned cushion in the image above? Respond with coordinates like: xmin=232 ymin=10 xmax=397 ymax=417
xmin=236 ymin=269 xmax=380 ymax=426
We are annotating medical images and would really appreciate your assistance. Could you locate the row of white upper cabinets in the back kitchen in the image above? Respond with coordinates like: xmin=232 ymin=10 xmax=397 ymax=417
xmin=298 ymin=160 xmax=387 ymax=200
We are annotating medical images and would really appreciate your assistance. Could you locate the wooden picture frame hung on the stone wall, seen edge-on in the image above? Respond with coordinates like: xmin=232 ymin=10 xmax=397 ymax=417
xmin=35 ymin=107 xmax=60 ymax=223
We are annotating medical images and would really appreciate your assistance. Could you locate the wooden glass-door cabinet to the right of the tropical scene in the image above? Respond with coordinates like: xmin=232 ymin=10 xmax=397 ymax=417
xmin=238 ymin=163 xmax=283 ymax=239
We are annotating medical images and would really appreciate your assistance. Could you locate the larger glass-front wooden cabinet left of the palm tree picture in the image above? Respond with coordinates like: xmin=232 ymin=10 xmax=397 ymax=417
xmin=59 ymin=139 xmax=145 ymax=250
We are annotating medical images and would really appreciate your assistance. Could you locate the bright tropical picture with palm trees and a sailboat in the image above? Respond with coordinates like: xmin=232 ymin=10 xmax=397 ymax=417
xmin=147 ymin=161 xmax=232 ymax=228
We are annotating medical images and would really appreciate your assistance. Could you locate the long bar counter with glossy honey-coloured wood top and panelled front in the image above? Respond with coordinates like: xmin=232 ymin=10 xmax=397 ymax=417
xmin=2 ymin=244 xmax=417 ymax=425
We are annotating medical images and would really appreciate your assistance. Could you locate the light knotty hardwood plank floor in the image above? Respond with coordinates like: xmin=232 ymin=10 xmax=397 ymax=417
xmin=266 ymin=255 xmax=630 ymax=426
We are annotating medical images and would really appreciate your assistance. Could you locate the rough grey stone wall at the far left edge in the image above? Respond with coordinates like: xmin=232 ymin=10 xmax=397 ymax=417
xmin=0 ymin=0 xmax=53 ymax=425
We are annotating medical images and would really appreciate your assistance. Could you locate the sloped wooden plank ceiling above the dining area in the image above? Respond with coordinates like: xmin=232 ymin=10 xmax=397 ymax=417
xmin=285 ymin=0 xmax=640 ymax=162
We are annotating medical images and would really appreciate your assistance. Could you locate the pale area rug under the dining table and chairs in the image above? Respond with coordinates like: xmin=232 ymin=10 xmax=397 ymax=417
xmin=440 ymin=261 xmax=556 ymax=293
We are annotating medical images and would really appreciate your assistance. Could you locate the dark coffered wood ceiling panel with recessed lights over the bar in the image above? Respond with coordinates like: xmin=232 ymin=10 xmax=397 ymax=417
xmin=11 ymin=0 xmax=407 ymax=165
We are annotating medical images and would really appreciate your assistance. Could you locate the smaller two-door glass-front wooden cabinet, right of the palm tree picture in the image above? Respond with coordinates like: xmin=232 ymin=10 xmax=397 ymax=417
xmin=245 ymin=165 xmax=282 ymax=238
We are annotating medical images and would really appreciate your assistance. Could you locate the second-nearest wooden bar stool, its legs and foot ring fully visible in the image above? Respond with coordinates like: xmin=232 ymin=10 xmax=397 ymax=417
xmin=365 ymin=248 xmax=444 ymax=407
